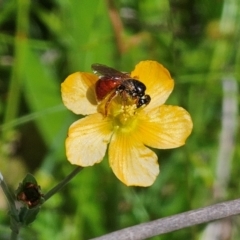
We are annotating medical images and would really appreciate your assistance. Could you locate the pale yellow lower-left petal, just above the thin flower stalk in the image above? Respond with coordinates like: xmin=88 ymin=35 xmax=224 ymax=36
xmin=66 ymin=113 xmax=112 ymax=167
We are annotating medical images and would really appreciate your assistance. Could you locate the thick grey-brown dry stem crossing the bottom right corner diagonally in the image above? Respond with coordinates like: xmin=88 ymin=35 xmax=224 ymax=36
xmin=92 ymin=199 xmax=240 ymax=240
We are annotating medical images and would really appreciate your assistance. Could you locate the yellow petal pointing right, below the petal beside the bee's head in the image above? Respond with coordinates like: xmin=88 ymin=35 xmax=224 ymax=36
xmin=137 ymin=105 xmax=193 ymax=149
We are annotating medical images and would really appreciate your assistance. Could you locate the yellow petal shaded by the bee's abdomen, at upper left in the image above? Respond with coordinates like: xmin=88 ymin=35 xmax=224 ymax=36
xmin=61 ymin=72 xmax=98 ymax=115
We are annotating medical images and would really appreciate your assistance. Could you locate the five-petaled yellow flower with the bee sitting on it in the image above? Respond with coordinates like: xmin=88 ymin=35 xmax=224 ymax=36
xmin=61 ymin=61 xmax=192 ymax=186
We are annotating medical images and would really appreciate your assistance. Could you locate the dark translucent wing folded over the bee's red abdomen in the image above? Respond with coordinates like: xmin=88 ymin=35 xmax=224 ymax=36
xmin=92 ymin=63 xmax=129 ymax=78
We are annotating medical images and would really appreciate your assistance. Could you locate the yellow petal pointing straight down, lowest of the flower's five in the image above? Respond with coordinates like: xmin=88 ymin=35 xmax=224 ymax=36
xmin=109 ymin=131 xmax=159 ymax=187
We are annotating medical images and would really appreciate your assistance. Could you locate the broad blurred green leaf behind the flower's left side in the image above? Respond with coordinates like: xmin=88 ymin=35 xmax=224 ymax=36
xmin=23 ymin=46 xmax=74 ymax=146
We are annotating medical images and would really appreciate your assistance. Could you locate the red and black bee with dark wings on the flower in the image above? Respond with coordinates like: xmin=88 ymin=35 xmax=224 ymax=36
xmin=92 ymin=63 xmax=151 ymax=116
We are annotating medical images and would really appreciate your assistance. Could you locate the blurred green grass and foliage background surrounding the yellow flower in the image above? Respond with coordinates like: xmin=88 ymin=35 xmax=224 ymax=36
xmin=0 ymin=0 xmax=240 ymax=240
